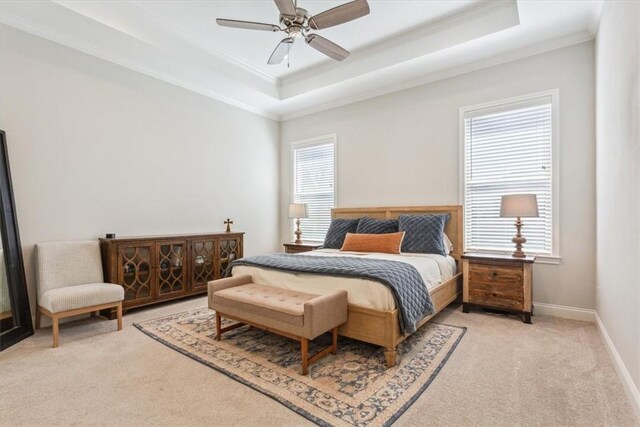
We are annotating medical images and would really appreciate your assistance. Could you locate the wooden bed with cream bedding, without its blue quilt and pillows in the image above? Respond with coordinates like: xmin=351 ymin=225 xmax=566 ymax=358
xmin=232 ymin=205 xmax=462 ymax=367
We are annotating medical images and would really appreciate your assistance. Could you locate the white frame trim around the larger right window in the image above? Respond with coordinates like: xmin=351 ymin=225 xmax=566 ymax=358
xmin=458 ymin=88 xmax=561 ymax=264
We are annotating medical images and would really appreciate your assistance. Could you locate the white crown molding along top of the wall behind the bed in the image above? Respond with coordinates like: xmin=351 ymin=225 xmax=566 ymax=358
xmin=280 ymin=31 xmax=594 ymax=121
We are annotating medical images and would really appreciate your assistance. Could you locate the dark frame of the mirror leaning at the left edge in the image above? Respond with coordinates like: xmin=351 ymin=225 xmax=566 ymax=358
xmin=0 ymin=130 xmax=33 ymax=350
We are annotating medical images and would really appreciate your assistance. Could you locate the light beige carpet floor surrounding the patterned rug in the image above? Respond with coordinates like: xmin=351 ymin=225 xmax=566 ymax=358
xmin=0 ymin=297 xmax=639 ymax=426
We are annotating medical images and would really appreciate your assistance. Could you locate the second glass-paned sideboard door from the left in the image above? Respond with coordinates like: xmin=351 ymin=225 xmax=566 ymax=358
xmin=156 ymin=240 xmax=187 ymax=298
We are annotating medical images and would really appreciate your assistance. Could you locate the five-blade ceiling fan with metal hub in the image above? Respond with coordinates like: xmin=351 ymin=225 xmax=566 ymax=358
xmin=216 ymin=0 xmax=369 ymax=65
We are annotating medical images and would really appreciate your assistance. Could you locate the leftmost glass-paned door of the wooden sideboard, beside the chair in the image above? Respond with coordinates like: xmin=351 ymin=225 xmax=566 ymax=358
xmin=117 ymin=243 xmax=154 ymax=307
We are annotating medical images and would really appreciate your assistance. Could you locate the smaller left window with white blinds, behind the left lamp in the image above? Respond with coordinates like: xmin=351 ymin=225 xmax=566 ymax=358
xmin=292 ymin=136 xmax=336 ymax=242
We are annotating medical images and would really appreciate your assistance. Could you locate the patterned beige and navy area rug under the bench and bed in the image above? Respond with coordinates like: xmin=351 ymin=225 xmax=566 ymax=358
xmin=135 ymin=309 xmax=466 ymax=426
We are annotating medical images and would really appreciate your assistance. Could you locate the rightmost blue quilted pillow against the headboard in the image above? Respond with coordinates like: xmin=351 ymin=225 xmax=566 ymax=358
xmin=398 ymin=214 xmax=451 ymax=255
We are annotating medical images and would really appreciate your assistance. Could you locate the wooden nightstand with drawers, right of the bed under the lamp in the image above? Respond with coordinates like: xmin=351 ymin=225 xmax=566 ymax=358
xmin=462 ymin=253 xmax=535 ymax=324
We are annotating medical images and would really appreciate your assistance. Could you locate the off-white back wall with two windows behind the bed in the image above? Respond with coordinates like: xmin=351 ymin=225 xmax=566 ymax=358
xmin=280 ymin=42 xmax=595 ymax=309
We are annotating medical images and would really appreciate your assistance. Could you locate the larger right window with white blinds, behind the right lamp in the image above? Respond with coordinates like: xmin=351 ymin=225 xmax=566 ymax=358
xmin=460 ymin=91 xmax=558 ymax=256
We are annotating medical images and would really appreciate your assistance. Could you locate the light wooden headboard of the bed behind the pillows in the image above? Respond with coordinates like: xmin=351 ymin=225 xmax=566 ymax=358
xmin=331 ymin=205 xmax=463 ymax=260
